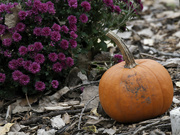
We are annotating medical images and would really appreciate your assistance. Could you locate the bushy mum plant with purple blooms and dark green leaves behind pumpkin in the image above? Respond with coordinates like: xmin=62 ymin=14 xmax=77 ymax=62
xmin=0 ymin=0 xmax=142 ymax=97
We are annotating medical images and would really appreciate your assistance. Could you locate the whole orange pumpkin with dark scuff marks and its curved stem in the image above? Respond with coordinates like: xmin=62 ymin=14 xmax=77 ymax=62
xmin=99 ymin=31 xmax=173 ymax=123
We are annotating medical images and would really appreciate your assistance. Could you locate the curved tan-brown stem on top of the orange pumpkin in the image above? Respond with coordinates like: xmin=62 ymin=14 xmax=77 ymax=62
xmin=106 ymin=31 xmax=137 ymax=68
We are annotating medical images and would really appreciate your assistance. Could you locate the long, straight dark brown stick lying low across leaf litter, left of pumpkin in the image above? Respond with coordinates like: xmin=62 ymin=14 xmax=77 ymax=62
xmin=20 ymin=109 xmax=91 ymax=125
